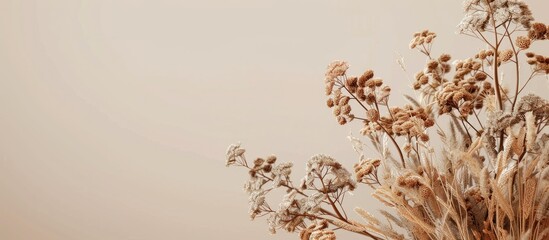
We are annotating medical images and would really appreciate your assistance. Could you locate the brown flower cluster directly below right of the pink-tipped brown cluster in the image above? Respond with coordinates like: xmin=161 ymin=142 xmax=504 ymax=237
xmin=361 ymin=105 xmax=435 ymax=142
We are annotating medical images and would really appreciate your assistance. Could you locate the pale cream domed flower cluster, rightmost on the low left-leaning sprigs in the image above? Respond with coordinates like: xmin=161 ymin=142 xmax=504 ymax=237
xmin=301 ymin=154 xmax=356 ymax=193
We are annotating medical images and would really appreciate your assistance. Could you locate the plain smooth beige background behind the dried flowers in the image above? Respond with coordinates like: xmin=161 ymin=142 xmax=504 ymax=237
xmin=0 ymin=0 xmax=549 ymax=240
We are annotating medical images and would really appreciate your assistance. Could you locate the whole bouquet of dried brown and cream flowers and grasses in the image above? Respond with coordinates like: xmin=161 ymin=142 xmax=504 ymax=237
xmin=226 ymin=0 xmax=549 ymax=240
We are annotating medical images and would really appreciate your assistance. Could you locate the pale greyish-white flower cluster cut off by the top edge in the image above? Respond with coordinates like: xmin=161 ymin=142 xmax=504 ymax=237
xmin=458 ymin=0 xmax=534 ymax=33
